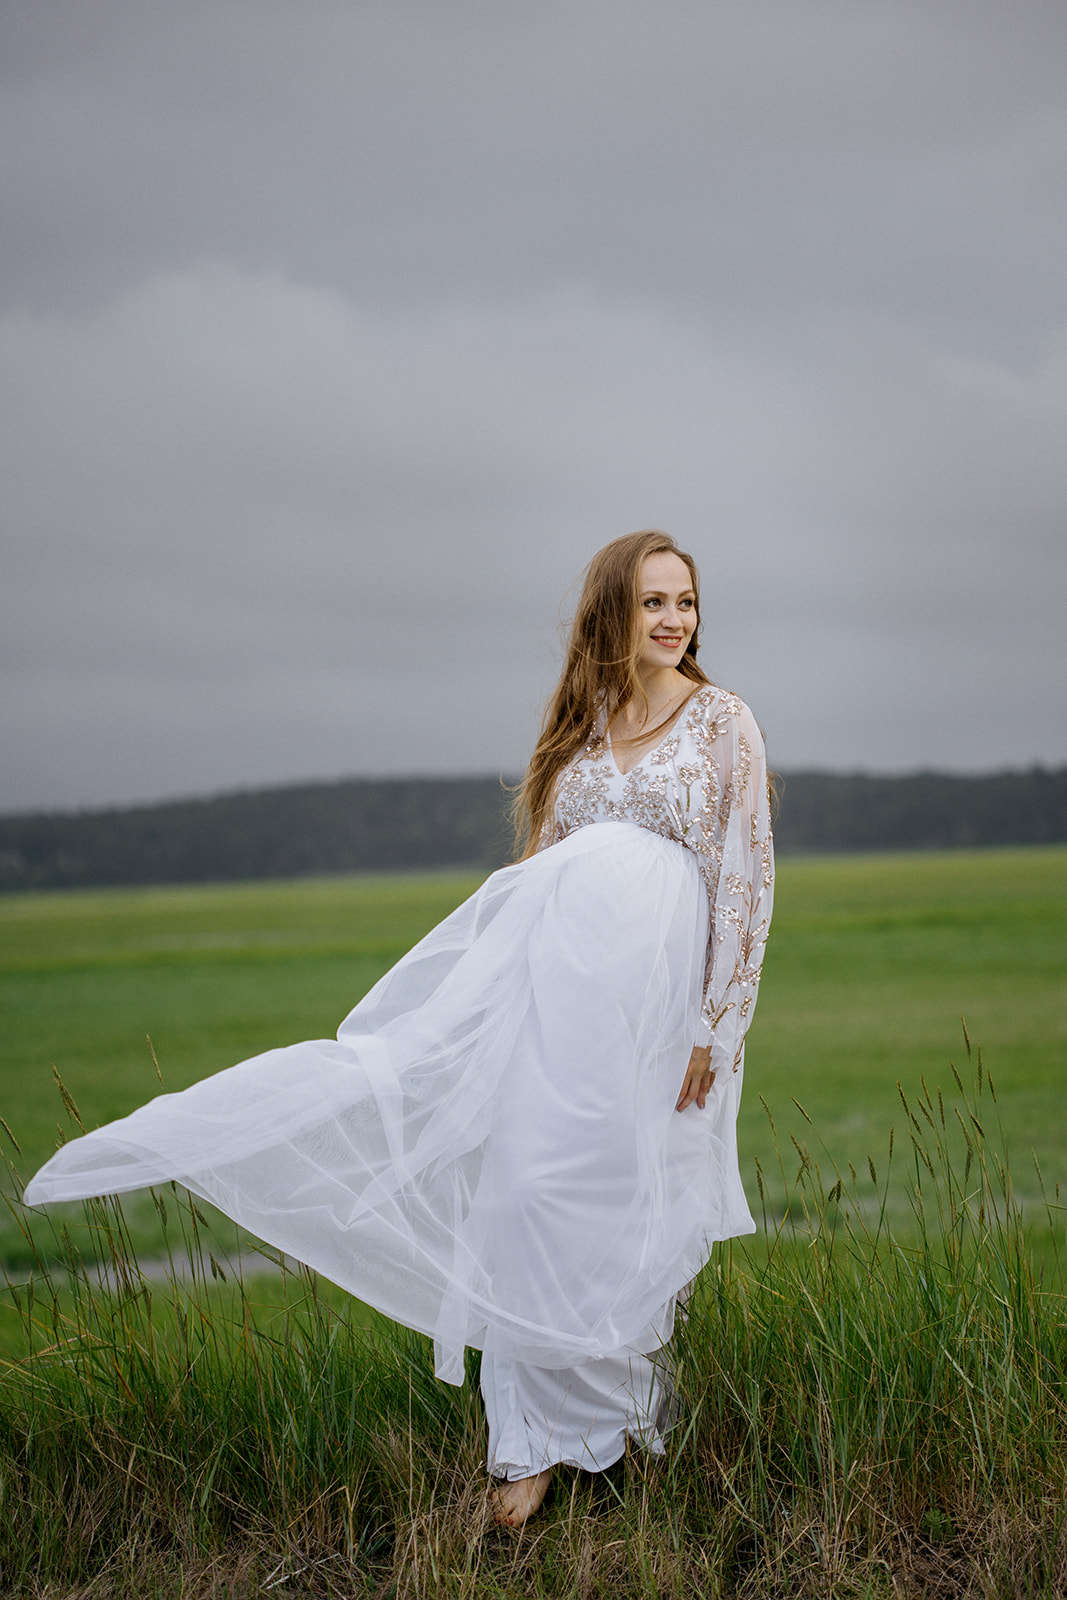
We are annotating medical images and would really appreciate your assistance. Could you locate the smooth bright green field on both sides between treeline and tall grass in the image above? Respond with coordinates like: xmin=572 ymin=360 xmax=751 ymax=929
xmin=0 ymin=848 xmax=1067 ymax=1264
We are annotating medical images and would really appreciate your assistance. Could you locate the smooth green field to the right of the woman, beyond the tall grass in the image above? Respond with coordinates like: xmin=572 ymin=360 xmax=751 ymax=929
xmin=751 ymin=846 xmax=1067 ymax=1221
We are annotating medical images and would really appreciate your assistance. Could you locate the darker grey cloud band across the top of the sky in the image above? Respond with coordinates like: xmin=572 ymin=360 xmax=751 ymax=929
xmin=5 ymin=0 xmax=1067 ymax=338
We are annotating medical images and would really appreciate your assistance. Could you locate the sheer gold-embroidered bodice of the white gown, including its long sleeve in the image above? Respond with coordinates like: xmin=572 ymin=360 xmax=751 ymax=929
xmin=539 ymin=685 xmax=774 ymax=1069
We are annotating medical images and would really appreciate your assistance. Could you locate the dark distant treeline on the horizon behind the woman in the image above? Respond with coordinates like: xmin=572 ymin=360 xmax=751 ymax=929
xmin=0 ymin=766 xmax=1067 ymax=890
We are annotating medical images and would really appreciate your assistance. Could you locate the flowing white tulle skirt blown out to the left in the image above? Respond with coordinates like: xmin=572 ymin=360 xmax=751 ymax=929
xmin=26 ymin=822 xmax=753 ymax=1382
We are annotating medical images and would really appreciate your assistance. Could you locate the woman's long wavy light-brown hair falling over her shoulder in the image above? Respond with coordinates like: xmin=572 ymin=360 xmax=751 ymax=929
xmin=512 ymin=528 xmax=709 ymax=856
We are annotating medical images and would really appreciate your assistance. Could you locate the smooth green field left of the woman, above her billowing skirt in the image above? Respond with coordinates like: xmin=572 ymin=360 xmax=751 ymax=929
xmin=0 ymin=874 xmax=478 ymax=1266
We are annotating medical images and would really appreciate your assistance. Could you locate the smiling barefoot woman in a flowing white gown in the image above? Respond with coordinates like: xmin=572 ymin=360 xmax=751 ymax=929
xmin=26 ymin=533 xmax=773 ymax=1525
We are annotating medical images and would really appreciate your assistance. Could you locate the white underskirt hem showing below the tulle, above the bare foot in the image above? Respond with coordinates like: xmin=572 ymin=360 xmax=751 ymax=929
xmin=482 ymin=1350 xmax=672 ymax=1478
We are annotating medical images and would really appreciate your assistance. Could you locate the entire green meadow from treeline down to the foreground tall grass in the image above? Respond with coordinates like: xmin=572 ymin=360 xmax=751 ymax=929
xmin=0 ymin=848 xmax=1067 ymax=1600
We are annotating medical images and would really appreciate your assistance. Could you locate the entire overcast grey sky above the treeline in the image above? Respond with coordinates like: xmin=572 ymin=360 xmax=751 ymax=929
xmin=0 ymin=0 xmax=1067 ymax=811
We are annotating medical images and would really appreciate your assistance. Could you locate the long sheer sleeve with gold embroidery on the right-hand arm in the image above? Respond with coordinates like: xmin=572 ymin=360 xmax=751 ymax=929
xmin=680 ymin=694 xmax=774 ymax=1072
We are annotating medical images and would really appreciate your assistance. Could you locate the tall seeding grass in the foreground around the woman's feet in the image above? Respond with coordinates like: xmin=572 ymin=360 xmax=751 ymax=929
xmin=0 ymin=1030 xmax=1067 ymax=1600
